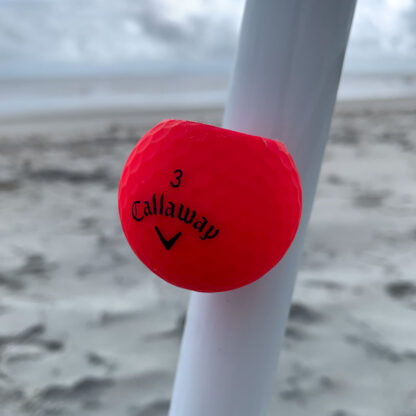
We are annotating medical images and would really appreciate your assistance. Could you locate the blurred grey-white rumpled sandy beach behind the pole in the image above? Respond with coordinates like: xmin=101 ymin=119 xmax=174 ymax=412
xmin=0 ymin=100 xmax=416 ymax=416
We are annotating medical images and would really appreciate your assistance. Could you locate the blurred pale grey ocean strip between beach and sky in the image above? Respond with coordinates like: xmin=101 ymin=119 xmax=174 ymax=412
xmin=0 ymin=71 xmax=416 ymax=119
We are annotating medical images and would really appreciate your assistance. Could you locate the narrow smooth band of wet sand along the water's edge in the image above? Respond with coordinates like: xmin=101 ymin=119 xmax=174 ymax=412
xmin=0 ymin=97 xmax=416 ymax=141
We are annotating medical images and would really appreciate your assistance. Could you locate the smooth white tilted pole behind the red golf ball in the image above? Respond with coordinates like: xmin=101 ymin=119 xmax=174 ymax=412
xmin=169 ymin=0 xmax=355 ymax=416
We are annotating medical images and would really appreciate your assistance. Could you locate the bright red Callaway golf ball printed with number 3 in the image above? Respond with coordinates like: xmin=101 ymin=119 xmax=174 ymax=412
xmin=118 ymin=120 xmax=302 ymax=292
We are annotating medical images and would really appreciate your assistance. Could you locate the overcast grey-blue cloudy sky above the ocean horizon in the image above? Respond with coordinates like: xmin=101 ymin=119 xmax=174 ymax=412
xmin=0 ymin=0 xmax=416 ymax=72
